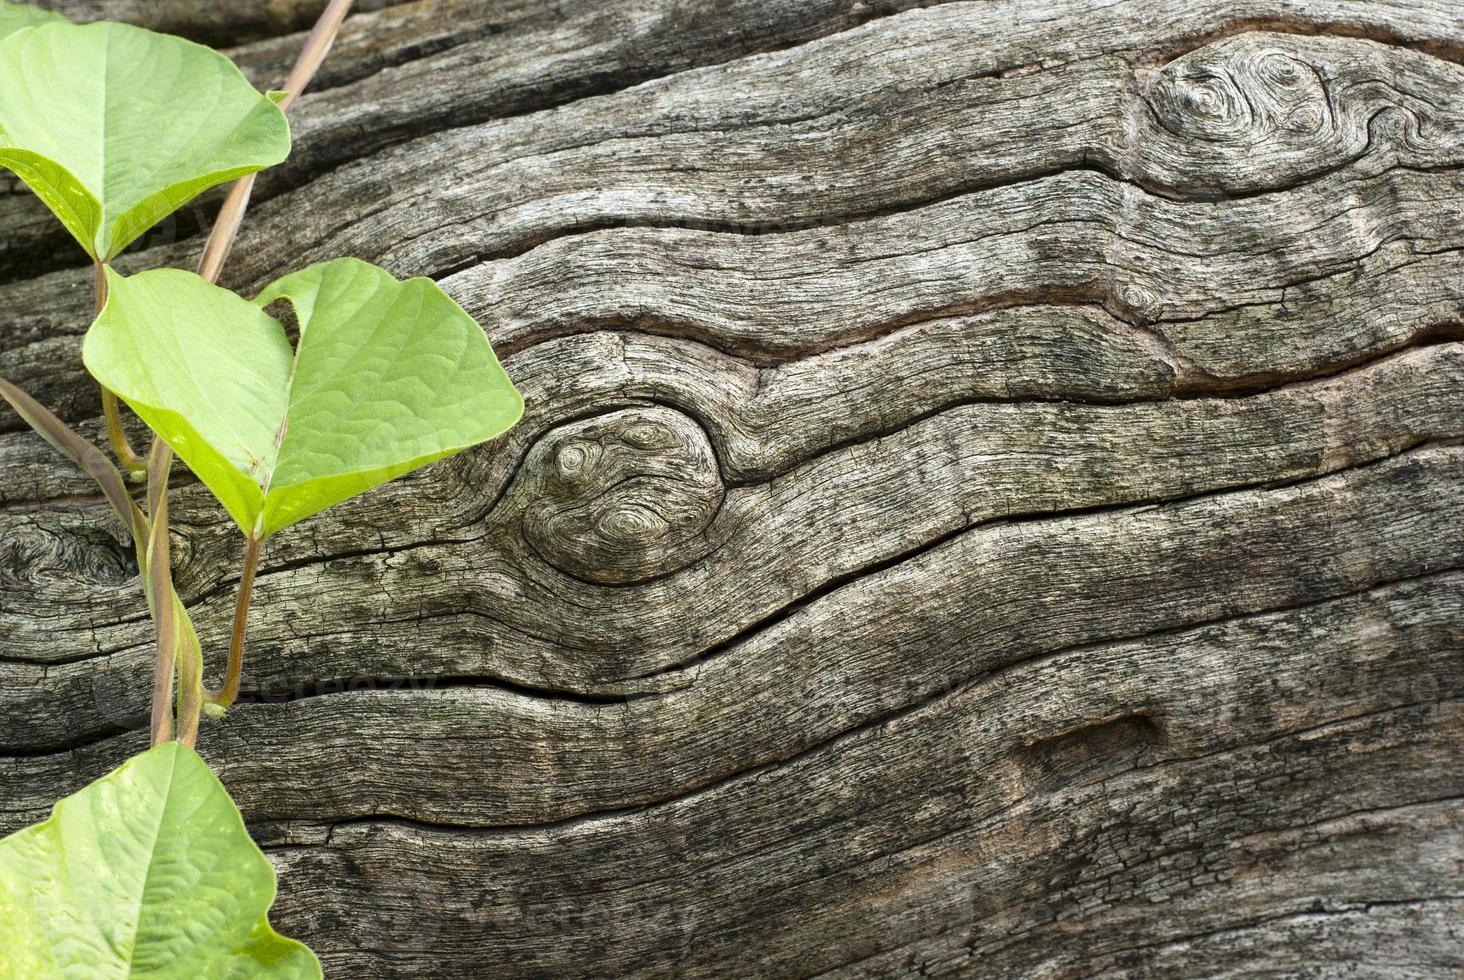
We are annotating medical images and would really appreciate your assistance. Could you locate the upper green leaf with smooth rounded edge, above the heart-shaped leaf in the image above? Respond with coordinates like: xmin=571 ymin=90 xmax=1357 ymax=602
xmin=0 ymin=21 xmax=290 ymax=261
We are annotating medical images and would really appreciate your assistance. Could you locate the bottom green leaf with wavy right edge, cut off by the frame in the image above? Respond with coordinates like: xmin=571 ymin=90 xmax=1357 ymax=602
xmin=0 ymin=741 xmax=321 ymax=980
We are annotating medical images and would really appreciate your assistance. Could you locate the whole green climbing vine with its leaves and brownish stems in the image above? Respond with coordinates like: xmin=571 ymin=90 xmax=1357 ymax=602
xmin=0 ymin=0 xmax=523 ymax=980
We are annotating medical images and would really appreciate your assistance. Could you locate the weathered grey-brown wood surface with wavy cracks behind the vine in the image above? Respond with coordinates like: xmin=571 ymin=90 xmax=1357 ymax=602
xmin=0 ymin=0 xmax=1464 ymax=977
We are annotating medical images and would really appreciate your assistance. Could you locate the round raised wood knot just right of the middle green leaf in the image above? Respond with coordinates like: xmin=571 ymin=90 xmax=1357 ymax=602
xmin=521 ymin=407 xmax=725 ymax=584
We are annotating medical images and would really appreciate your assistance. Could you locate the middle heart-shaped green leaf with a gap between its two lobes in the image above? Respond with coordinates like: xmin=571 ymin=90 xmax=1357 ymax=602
xmin=82 ymin=259 xmax=523 ymax=536
